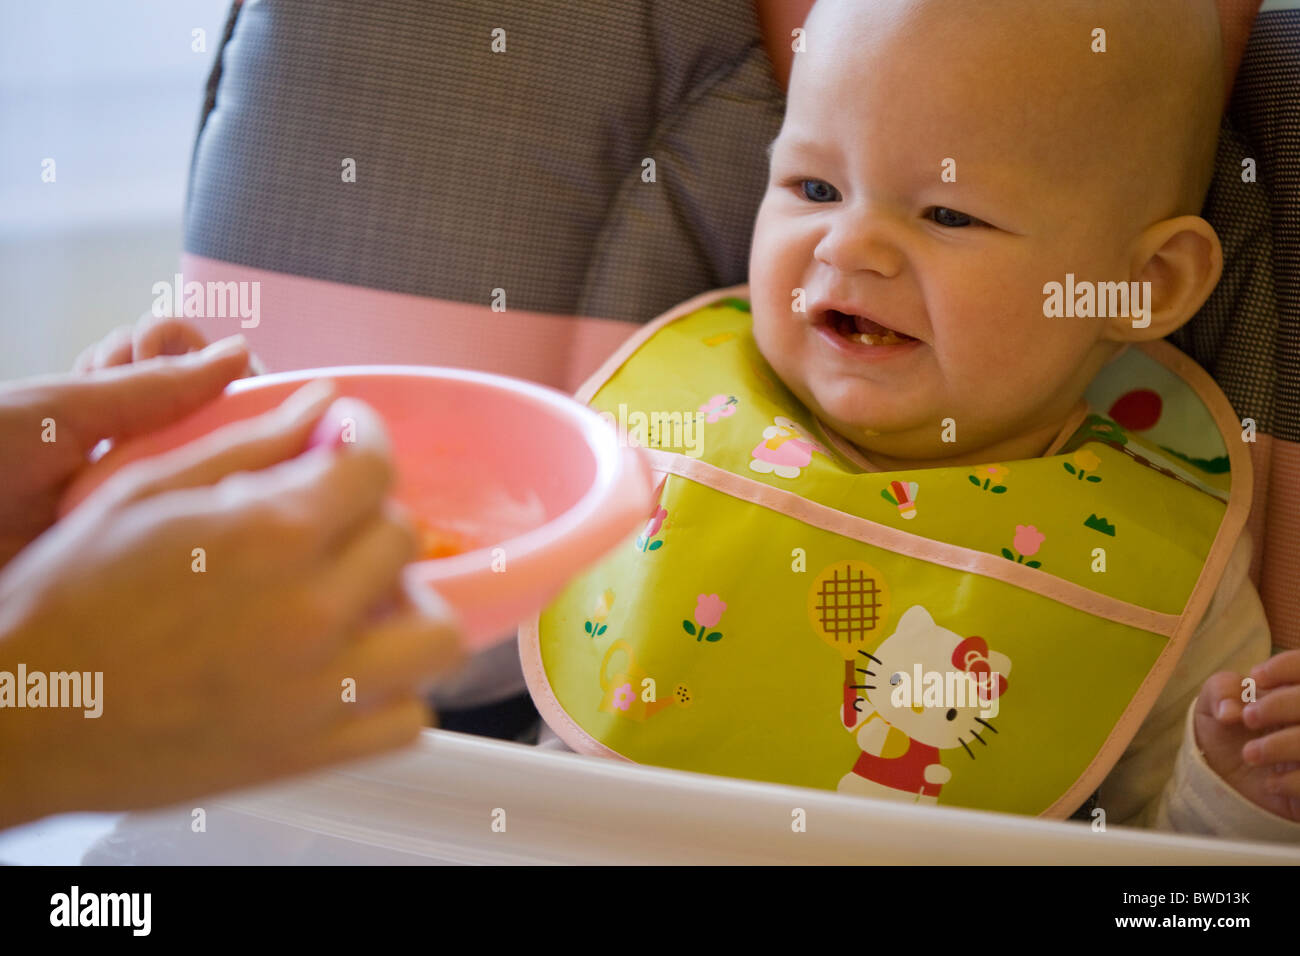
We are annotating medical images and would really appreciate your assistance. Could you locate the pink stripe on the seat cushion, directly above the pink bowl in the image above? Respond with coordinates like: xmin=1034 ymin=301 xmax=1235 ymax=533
xmin=181 ymin=254 xmax=640 ymax=393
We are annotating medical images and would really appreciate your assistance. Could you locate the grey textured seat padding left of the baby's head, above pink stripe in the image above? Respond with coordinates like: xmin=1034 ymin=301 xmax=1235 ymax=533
xmin=185 ymin=0 xmax=784 ymax=321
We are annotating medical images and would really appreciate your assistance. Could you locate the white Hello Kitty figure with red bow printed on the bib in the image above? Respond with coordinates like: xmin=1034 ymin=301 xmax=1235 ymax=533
xmin=836 ymin=605 xmax=1011 ymax=804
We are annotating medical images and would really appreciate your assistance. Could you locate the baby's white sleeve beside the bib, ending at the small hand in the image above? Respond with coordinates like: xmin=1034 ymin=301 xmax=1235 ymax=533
xmin=1097 ymin=532 xmax=1300 ymax=842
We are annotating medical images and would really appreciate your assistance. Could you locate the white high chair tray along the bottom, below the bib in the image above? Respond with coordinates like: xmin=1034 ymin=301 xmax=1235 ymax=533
xmin=83 ymin=730 xmax=1300 ymax=866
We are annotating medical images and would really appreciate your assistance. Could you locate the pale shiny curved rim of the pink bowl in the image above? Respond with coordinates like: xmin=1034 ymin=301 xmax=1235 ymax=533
xmin=226 ymin=364 xmax=628 ymax=583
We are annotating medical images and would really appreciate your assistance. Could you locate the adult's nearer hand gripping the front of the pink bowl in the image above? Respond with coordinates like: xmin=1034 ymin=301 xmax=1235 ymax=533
xmin=0 ymin=377 xmax=463 ymax=826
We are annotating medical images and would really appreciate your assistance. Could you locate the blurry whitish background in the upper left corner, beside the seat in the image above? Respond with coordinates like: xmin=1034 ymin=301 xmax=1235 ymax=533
xmin=0 ymin=0 xmax=230 ymax=378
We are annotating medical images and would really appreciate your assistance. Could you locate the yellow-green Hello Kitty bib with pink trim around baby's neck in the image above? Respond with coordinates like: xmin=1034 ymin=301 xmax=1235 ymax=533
xmin=520 ymin=287 xmax=1251 ymax=817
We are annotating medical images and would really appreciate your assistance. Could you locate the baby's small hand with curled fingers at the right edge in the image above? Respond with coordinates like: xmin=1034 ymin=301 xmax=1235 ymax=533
xmin=1193 ymin=649 xmax=1300 ymax=822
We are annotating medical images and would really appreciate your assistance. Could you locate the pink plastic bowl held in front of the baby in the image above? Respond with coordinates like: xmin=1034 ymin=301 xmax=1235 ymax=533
xmin=57 ymin=365 xmax=653 ymax=650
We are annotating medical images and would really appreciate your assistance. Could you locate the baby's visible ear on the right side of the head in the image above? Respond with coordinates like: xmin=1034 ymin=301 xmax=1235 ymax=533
xmin=1102 ymin=216 xmax=1223 ymax=342
